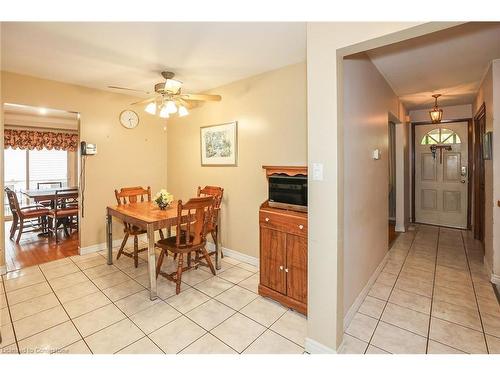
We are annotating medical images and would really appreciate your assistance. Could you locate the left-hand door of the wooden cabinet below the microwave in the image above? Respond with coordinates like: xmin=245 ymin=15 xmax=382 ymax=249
xmin=260 ymin=226 xmax=286 ymax=294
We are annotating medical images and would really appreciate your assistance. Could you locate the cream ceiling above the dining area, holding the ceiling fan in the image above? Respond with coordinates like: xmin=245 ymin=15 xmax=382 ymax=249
xmin=1 ymin=22 xmax=306 ymax=92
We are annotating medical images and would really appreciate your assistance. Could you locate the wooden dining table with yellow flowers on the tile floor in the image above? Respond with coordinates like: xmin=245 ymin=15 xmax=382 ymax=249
xmin=106 ymin=202 xmax=221 ymax=300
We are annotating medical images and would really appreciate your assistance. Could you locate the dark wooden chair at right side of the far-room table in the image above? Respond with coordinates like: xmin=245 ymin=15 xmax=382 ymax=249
xmin=47 ymin=189 xmax=78 ymax=243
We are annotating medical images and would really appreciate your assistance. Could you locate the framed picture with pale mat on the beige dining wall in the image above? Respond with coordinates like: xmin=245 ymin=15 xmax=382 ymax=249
xmin=200 ymin=121 xmax=238 ymax=167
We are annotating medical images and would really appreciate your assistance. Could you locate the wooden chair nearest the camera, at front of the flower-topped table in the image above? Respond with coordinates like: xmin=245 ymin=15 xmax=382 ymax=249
xmin=156 ymin=196 xmax=215 ymax=294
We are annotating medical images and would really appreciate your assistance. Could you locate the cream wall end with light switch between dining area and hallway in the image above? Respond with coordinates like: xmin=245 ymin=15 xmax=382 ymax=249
xmin=306 ymin=22 xmax=457 ymax=352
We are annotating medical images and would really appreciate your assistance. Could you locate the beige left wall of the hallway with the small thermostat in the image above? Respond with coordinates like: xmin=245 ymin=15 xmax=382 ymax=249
xmin=343 ymin=54 xmax=404 ymax=314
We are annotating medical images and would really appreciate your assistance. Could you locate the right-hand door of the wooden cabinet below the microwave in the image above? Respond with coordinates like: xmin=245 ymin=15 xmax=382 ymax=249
xmin=286 ymin=234 xmax=307 ymax=303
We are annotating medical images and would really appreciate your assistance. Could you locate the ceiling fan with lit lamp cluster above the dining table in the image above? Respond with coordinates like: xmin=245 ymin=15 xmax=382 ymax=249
xmin=108 ymin=72 xmax=222 ymax=118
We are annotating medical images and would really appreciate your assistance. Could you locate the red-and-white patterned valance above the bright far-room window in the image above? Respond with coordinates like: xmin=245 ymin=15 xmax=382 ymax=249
xmin=4 ymin=129 xmax=78 ymax=151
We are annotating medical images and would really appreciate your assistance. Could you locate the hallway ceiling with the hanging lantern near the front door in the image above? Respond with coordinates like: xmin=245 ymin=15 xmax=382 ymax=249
xmin=368 ymin=22 xmax=500 ymax=110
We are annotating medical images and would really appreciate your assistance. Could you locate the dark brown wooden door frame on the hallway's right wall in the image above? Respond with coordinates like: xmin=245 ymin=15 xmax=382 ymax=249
xmin=473 ymin=102 xmax=486 ymax=247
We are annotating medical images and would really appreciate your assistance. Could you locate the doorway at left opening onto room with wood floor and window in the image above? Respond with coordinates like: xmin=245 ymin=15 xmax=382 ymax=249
xmin=2 ymin=103 xmax=79 ymax=271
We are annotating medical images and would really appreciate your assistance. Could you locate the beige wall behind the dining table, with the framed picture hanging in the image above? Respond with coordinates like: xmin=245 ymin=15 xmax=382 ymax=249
xmin=167 ymin=63 xmax=307 ymax=257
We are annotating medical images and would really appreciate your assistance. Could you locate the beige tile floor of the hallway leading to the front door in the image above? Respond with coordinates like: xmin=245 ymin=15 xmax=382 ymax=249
xmin=342 ymin=225 xmax=500 ymax=354
